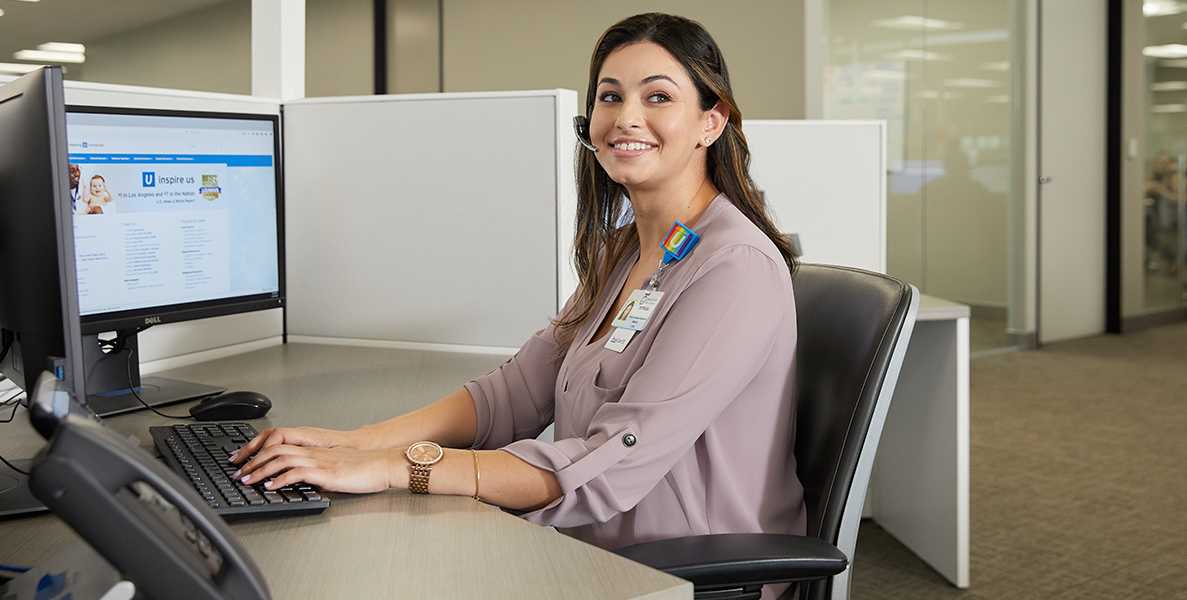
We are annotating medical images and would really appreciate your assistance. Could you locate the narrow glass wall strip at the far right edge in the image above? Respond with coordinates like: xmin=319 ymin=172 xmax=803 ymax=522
xmin=1142 ymin=1 xmax=1187 ymax=310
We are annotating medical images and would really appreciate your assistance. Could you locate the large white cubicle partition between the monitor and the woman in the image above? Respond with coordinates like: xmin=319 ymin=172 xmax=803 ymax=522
xmin=277 ymin=90 xmax=577 ymax=353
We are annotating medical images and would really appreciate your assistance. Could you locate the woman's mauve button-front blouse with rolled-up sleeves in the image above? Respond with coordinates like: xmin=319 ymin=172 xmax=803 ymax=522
xmin=465 ymin=196 xmax=806 ymax=556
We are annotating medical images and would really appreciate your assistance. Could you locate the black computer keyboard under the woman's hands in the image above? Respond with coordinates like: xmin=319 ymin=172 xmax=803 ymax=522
xmin=148 ymin=423 xmax=330 ymax=520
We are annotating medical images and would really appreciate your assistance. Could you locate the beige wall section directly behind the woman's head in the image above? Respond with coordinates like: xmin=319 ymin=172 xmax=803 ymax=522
xmin=444 ymin=0 xmax=804 ymax=119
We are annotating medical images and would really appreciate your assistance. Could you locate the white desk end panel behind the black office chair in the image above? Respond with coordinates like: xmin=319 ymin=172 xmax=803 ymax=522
xmin=857 ymin=296 xmax=969 ymax=588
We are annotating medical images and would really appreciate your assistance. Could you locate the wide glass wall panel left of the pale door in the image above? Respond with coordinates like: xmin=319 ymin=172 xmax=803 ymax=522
xmin=823 ymin=0 xmax=1022 ymax=352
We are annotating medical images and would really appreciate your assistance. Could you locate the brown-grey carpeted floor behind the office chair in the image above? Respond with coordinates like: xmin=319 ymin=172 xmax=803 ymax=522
xmin=852 ymin=323 xmax=1187 ymax=600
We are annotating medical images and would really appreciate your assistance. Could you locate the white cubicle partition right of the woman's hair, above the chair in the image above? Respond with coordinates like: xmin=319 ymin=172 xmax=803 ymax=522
xmin=742 ymin=120 xmax=887 ymax=273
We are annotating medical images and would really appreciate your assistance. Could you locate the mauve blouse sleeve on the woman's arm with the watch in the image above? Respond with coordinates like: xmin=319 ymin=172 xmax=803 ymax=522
xmin=506 ymin=246 xmax=794 ymax=528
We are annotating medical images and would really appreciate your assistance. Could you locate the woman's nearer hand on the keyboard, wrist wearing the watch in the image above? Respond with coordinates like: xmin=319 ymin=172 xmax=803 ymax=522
xmin=235 ymin=443 xmax=406 ymax=493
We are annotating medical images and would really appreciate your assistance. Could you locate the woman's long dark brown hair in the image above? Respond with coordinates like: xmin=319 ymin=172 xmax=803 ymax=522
xmin=554 ymin=13 xmax=796 ymax=358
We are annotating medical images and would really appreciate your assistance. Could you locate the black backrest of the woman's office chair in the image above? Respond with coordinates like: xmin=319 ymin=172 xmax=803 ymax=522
xmin=793 ymin=265 xmax=912 ymax=539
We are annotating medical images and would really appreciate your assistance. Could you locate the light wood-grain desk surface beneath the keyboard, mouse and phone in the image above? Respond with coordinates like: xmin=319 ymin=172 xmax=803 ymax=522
xmin=0 ymin=343 xmax=692 ymax=600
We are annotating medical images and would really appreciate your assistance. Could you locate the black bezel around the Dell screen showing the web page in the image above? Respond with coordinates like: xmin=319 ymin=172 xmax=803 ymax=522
xmin=65 ymin=105 xmax=286 ymax=335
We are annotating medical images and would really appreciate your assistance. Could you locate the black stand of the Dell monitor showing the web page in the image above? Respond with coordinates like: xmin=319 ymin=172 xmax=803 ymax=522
xmin=82 ymin=329 xmax=227 ymax=417
